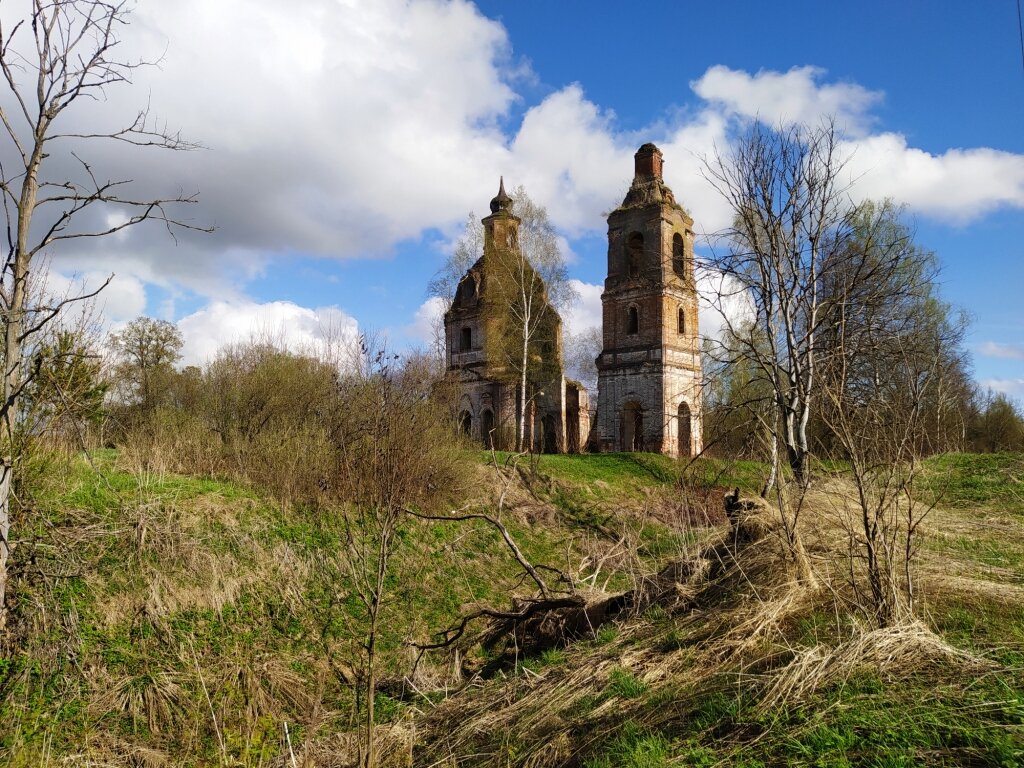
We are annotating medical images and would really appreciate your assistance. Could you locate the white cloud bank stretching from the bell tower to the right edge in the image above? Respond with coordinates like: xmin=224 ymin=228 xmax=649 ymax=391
xmin=679 ymin=66 xmax=1024 ymax=231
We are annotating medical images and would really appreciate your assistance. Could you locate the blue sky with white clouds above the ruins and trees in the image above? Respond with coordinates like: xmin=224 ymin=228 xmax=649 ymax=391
xmin=8 ymin=0 xmax=1024 ymax=398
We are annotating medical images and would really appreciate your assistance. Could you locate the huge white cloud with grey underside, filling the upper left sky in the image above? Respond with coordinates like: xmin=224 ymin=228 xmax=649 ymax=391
xmin=4 ymin=0 xmax=516 ymax=295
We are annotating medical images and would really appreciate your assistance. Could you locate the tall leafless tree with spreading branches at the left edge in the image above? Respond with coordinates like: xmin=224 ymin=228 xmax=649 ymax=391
xmin=0 ymin=0 xmax=205 ymax=628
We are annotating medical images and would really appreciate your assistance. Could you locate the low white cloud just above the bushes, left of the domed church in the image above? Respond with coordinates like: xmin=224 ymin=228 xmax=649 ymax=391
xmin=178 ymin=301 xmax=358 ymax=366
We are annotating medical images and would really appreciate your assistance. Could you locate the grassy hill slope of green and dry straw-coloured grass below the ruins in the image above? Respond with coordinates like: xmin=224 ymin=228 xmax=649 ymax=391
xmin=0 ymin=453 xmax=1024 ymax=768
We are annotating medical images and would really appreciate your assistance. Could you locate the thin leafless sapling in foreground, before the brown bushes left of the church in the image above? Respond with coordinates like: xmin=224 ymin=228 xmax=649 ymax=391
xmin=323 ymin=346 xmax=459 ymax=768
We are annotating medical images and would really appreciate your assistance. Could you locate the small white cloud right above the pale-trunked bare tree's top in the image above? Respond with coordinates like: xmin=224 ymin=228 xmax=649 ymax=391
xmin=690 ymin=65 xmax=883 ymax=134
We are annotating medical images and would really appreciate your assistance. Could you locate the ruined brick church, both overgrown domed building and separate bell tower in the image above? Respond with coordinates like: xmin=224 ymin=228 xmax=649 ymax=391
xmin=444 ymin=143 xmax=701 ymax=456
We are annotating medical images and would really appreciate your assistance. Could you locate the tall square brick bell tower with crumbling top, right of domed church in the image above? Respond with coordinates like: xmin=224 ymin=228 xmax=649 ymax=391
xmin=597 ymin=143 xmax=702 ymax=456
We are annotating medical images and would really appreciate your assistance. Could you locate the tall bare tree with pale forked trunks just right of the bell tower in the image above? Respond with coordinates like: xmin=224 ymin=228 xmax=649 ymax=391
xmin=705 ymin=123 xmax=854 ymax=487
